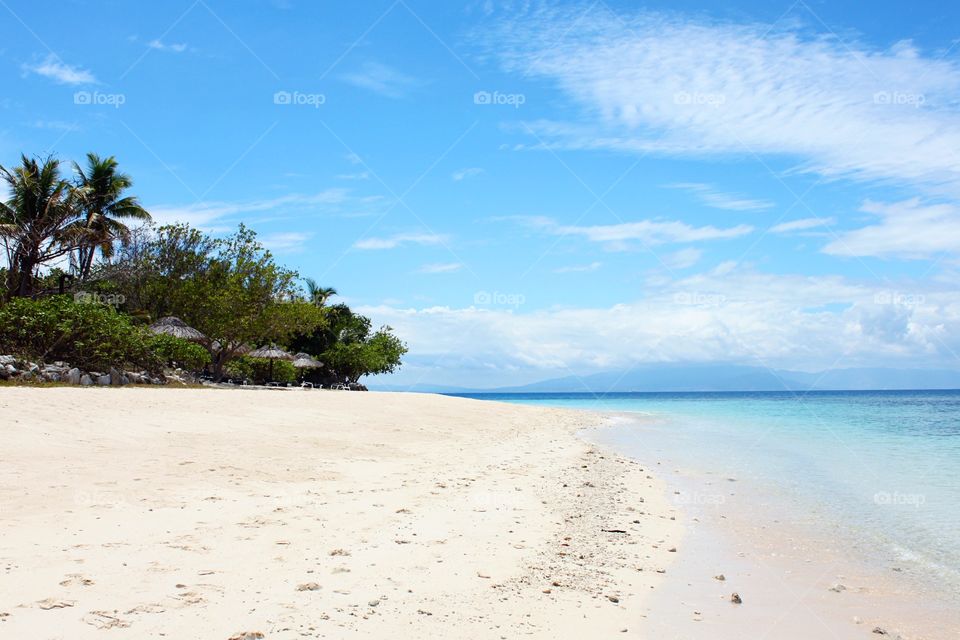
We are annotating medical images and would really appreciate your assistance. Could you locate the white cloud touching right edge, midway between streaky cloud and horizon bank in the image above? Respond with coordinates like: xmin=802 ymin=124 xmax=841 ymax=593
xmin=823 ymin=198 xmax=960 ymax=259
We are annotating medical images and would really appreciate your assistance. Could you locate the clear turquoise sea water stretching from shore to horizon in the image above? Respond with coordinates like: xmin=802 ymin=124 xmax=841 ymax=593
xmin=454 ymin=391 xmax=960 ymax=594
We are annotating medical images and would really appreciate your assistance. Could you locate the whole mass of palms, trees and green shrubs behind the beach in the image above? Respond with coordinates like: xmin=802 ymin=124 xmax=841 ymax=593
xmin=0 ymin=154 xmax=406 ymax=384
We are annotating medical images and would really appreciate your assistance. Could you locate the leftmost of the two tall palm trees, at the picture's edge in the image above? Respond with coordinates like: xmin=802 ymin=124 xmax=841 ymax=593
xmin=0 ymin=155 xmax=81 ymax=296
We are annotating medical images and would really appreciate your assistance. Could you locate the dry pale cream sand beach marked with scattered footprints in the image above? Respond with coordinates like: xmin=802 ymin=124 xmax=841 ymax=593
xmin=0 ymin=387 xmax=684 ymax=640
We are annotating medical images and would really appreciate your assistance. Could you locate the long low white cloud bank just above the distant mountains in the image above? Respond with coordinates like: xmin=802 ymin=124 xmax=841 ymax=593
xmin=361 ymin=266 xmax=960 ymax=384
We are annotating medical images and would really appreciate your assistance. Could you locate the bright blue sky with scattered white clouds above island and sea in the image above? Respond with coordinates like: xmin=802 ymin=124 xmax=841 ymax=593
xmin=0 ymin=0 xmax=960 ymax=387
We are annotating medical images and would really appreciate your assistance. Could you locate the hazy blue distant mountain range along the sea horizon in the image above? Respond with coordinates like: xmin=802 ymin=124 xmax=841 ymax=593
xmin=377 ymin=363 xmax=960 ymax=393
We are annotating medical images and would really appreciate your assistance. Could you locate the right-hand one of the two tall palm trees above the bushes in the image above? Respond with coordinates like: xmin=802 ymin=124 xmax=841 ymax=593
xmin=73 ymin=153 xmax=150 ymax=280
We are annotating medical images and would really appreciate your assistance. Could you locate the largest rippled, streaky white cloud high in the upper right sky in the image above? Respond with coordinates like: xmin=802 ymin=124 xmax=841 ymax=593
xmin=488 ymin=6 xmax=960 ymax=196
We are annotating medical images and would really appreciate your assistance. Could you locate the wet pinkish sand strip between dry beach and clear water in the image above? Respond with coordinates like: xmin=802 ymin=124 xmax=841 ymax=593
xmin=591 ymin=414 xmax=960 ymax=640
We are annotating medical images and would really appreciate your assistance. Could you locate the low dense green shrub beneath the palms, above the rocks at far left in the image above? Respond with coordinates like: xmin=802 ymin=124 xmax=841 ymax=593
xmin=0 ymin=296 xmax=159 ymax=371
